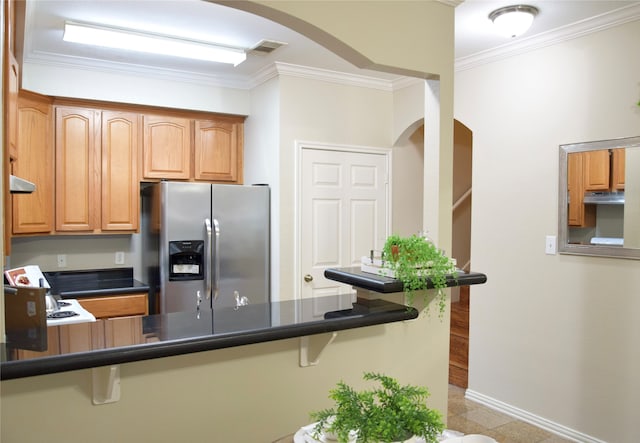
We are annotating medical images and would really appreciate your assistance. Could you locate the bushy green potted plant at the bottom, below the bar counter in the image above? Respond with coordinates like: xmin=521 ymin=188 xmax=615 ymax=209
xmin=311 ymin=372 xmax=444 ymax=443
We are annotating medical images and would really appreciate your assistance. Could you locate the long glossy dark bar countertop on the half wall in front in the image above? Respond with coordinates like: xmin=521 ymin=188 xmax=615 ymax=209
xmin=0 ymin=295 xmax=418 ymax=380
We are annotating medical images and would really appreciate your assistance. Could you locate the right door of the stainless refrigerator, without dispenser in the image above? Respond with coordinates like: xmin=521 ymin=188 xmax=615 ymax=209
xmin=212 ymin=185 xmax=270 ymax=310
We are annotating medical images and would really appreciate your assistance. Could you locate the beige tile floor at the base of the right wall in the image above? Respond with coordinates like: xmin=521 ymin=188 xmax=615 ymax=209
xmin=274 ymin=385 xmax=570 ymax=443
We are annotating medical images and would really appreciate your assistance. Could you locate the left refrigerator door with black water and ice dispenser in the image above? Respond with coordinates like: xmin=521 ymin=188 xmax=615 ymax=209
xmin=159 ymin=182 xmax=212 ymax=314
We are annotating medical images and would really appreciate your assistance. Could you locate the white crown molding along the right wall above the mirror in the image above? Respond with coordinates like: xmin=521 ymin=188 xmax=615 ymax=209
xmin=455 ymin=3 xmax=640 ymax=72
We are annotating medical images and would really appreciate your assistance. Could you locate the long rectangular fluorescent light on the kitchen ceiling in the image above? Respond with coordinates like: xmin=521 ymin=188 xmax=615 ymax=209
xmin=63 ymin=22 xmax=247 ymax=66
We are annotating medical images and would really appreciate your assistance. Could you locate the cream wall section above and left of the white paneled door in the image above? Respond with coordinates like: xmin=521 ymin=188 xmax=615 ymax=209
xmin=278 ymin=76 xmax=391 ymax=298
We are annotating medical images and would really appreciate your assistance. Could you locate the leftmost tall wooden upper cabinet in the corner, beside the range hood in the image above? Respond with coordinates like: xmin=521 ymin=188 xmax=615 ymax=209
xmin=11 ymin=94 xmax=54 ymax=234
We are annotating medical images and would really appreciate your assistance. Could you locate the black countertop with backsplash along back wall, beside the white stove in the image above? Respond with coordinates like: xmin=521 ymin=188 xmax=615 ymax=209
xmin=43 ymin=268 xmax=149 ymax=299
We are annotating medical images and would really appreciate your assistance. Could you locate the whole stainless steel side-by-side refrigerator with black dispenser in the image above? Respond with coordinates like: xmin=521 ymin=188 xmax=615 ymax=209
xmin=141 ymin=181 xmax=270 ymax=314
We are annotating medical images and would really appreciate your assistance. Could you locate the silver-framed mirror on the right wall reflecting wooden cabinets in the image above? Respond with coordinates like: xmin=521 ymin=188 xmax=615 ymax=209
xmin=558 ymin=136 xmax=640 ymax=259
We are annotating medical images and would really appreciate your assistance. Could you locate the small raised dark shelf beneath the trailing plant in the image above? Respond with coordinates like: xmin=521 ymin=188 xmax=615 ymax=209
xmin=324 ymin=266 xmax=487 ymax=294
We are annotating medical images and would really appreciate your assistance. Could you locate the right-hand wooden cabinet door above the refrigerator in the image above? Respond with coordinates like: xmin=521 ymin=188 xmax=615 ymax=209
xmin=194 ymin=120 xmax=243 ymax=183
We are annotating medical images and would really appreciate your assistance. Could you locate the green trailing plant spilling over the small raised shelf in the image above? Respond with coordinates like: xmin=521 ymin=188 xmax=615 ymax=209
xmin=382 ymin=235 xmax=458 ymax=316
